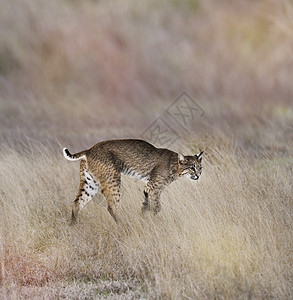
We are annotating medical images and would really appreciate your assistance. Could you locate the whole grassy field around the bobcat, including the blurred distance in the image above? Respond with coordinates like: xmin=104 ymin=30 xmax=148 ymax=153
xmin=0 ymin=0 xmax=293 ymax=299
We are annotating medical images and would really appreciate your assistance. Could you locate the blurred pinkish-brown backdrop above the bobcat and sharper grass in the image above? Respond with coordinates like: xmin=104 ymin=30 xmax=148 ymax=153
xmin=0 ymin=0 xmax=293 ymax=155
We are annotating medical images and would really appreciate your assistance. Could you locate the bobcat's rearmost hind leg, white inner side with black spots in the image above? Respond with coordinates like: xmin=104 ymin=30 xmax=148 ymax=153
xmin=71 ymin=161 xmax=99 ymax=224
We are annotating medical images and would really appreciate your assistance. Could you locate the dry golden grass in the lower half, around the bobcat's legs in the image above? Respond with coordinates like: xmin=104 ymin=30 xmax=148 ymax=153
xmin=0 ymin=140 xmax=293 ymax=299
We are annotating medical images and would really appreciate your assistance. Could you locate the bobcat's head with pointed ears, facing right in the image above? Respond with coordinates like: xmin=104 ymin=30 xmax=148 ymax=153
xmin=178 ymin=151 xmax=203 ymax=180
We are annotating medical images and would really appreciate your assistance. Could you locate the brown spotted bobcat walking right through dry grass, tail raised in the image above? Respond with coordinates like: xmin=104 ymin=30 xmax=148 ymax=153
xmin=63 ymin=139 xmax=203 ymax=223
